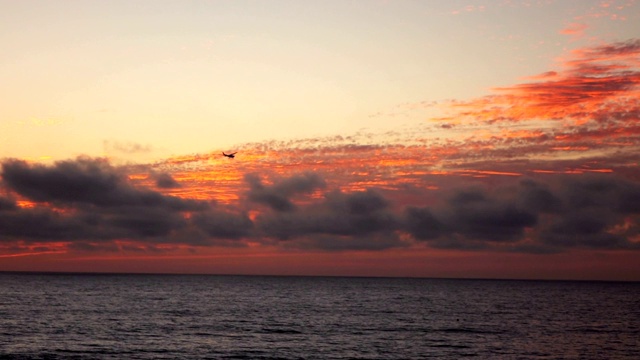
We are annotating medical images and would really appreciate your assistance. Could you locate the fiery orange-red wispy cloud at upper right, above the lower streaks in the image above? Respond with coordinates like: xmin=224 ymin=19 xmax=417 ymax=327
xmin=440 ymin=39 xmax=640 ymax=126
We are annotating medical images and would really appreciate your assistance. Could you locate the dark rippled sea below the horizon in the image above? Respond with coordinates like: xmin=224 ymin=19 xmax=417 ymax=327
xmin=0 ymin=273 xmax=640 ymax=359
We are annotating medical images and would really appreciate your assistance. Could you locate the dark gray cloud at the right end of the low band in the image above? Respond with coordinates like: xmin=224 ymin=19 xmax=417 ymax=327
xmin=404 ymin=175 xmax=640 ymax=253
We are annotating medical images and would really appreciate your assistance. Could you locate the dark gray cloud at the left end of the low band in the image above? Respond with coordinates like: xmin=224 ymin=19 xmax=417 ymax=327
xmin=0 ymin=158 xmax=252 ymax=249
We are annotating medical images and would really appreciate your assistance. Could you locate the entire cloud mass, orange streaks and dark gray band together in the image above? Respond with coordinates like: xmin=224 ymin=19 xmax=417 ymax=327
xmin=0 ymin=40 xmax=640 ymax=254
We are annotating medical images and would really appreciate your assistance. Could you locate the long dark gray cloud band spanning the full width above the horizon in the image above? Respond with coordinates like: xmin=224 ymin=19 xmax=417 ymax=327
xmin=0 ymin=158 xmax=640 ymax=253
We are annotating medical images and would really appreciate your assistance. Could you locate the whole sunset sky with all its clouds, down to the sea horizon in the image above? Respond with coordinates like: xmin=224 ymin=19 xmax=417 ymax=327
xmin=0 ymin=0 xmax=640 ymax=281
